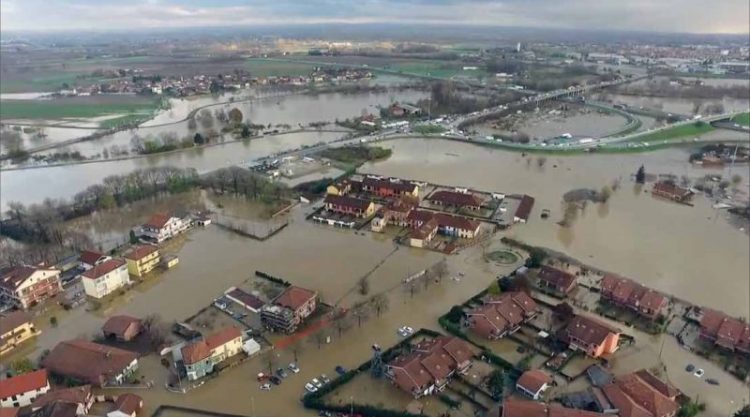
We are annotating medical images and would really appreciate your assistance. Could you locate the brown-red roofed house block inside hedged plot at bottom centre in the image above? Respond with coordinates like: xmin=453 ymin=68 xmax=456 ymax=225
xmin=386 ymin=336 xmax=474 ymax=398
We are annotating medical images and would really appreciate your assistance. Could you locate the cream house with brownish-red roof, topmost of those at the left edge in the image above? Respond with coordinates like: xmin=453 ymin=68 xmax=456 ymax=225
xmin=0 ymin=265 xmax=62 ymax=310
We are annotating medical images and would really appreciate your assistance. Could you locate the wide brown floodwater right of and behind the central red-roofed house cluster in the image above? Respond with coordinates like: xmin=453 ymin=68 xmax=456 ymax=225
xmin=361 ymin=139 xmax=750 ymax=317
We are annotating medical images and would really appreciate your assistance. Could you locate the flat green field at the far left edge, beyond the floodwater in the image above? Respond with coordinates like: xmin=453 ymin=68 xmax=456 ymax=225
xmin=0 ymin=96 xmax=159 ymax=123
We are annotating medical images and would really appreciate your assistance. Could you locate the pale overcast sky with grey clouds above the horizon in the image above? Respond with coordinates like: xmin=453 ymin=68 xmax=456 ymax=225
xmin=0 ymin=0 xmax=750 ymax=33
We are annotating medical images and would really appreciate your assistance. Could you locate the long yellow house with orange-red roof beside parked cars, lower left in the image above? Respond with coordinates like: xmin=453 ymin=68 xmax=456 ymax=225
xmin=179 ymin=326 xmax=242 ymax=381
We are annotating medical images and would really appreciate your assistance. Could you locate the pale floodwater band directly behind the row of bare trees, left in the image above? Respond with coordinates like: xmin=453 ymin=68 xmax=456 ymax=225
xmin=0 ymin=132 xmax=343 ymax=210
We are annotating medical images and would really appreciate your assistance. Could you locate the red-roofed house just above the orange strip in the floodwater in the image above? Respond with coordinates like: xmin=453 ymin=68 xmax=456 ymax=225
xmin=260 ymin=285 xmax=318 ymax=333
